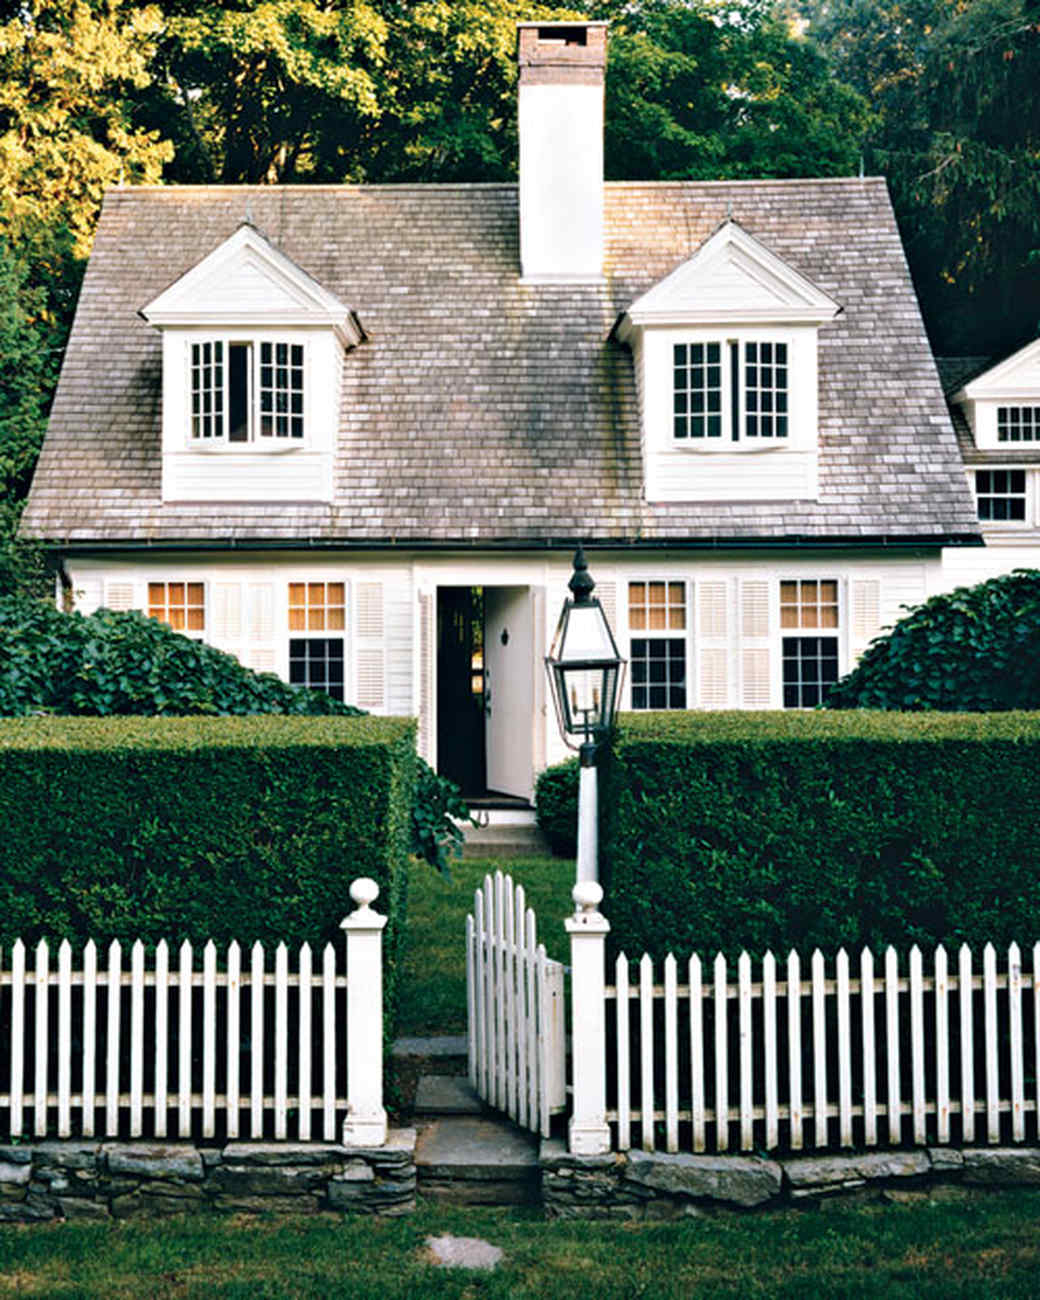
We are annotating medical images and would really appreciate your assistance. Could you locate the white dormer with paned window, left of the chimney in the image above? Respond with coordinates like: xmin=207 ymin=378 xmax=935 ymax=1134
xmin=140 ymin=225 xmax=364 ymax=501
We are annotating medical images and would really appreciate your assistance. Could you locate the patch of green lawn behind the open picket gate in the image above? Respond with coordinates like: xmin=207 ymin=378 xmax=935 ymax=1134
xmin=398 ymin=858 xmax=575 ymax=1035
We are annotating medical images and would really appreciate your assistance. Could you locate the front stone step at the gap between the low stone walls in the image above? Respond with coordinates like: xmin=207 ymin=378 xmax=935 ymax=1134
xmin=415 ymin=1115 xmax=541 ymax=1205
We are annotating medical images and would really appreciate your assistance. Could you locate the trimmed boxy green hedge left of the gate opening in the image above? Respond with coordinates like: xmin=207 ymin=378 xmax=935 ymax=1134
xmin=0 ymin=716 xmax=415 ymax=1005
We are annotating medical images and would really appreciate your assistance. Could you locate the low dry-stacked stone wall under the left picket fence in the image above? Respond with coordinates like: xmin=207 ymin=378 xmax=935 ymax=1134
xmin=0 ymin=1128 xmax=416 ymax=1223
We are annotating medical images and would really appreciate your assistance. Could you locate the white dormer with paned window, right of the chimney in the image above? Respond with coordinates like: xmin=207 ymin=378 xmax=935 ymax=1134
xmin=618 ymin=221 xmax=841 ymax=502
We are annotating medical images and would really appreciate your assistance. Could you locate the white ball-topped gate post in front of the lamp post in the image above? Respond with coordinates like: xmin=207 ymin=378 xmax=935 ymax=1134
xmin=564 ymin=880 xmax=610 ymax=1156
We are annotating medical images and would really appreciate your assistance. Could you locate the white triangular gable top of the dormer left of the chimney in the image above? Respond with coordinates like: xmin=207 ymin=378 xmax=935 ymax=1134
xmin=140 ymin=221 xmax=364 ymax=347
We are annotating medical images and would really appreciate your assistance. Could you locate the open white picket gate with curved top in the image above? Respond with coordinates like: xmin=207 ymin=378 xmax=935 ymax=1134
xmin=465 ymin=871 xmax=567 ymax=1138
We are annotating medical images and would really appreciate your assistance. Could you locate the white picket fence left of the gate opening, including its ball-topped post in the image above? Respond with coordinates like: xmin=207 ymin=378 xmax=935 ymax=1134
xmin=0 ymin=880 xmax=385 ymax=1144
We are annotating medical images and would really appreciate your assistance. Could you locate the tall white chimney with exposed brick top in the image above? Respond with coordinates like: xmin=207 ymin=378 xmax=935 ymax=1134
xmin=519 ymin=22 xmax=607 ymax=283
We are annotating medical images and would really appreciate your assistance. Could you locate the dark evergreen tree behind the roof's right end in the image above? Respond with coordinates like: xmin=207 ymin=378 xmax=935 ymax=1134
xmin=806 ymin=0 xmax=1040 ymax=355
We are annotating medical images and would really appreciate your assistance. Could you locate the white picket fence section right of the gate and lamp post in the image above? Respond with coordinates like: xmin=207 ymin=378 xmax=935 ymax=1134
xmin=598 ymin=944 xmax=1040 ymax=1152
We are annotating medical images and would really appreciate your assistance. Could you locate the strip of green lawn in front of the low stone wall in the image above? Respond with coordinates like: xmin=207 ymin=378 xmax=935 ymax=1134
xmin=0 ymin=1192 xmax=1040 ymax=1300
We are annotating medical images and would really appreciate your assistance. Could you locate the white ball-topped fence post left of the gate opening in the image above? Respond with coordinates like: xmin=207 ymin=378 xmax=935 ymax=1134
xmin=341 ymin=876 xmax=386 ymax=1147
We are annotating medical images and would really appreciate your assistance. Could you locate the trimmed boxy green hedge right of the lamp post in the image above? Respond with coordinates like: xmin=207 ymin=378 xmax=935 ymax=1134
xmin=601 ymin=712 xmax=1040 ymax=957
